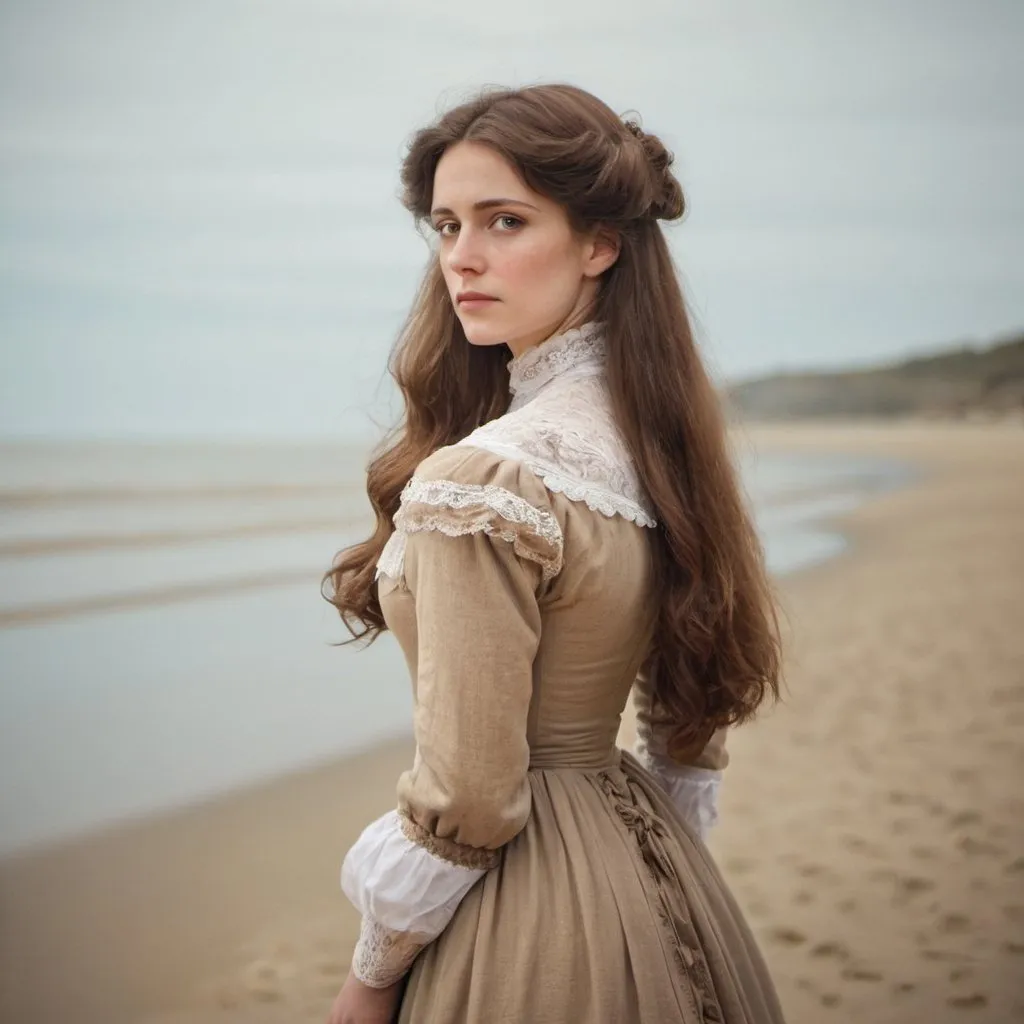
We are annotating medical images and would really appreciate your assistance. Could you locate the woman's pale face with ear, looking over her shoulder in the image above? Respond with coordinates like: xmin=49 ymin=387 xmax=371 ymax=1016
xmin=431 ymin=142 xmax=616 ymax=355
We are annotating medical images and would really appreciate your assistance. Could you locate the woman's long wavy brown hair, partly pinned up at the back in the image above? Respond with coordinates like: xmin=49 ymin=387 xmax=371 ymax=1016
xmin=325 ymin=85 xmax=780 ymax=756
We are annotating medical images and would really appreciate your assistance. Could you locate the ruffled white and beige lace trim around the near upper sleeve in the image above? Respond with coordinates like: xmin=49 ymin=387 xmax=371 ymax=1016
xmin=377 ymin=477 xmax=562 ymax=580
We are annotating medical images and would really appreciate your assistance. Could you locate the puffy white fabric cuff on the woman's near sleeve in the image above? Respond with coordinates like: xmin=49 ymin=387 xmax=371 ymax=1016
xmin=341 ymin=811 xmax=485 ymax=943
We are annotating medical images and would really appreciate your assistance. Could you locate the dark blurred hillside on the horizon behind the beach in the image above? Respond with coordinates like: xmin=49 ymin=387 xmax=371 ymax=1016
xmin=726 ymin=333 xmax=1024 ymax=420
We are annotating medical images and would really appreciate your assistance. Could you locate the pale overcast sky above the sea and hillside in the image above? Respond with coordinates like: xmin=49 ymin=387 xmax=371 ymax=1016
xmin=0 ymin=0 xmax=1024 ymax=437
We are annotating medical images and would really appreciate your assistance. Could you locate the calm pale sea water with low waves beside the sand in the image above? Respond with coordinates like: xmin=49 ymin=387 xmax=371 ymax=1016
xmin=0 ymin=441 xmax=910 ymax=856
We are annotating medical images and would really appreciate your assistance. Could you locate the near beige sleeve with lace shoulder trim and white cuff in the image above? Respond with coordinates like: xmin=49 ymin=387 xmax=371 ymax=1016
xmin=342 ymin=447 xmax=562 ymax=987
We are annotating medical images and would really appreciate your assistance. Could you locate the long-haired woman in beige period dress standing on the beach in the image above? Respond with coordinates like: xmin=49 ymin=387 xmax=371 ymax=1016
xmin=329 ymin=85 xmax=781 ymax=1024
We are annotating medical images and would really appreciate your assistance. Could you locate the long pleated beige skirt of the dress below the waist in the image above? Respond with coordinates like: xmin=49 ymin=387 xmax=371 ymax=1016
xmin=398 ymin=753 xmax=782 ymax=1024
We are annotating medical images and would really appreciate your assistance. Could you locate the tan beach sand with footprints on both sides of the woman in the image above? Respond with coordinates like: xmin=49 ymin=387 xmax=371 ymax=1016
xmin=0 ymin=424 xmax=1024 ymax=1024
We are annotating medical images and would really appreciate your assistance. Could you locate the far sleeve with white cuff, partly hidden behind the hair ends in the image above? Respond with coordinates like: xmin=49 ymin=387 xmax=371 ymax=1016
xmin=633 ymin=673 xmax=729 ymax=840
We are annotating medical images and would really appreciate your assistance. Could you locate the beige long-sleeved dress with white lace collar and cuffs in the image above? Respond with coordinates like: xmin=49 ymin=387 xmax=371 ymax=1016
xmin=342 ymin=325 xmax=782 ymax=1024
